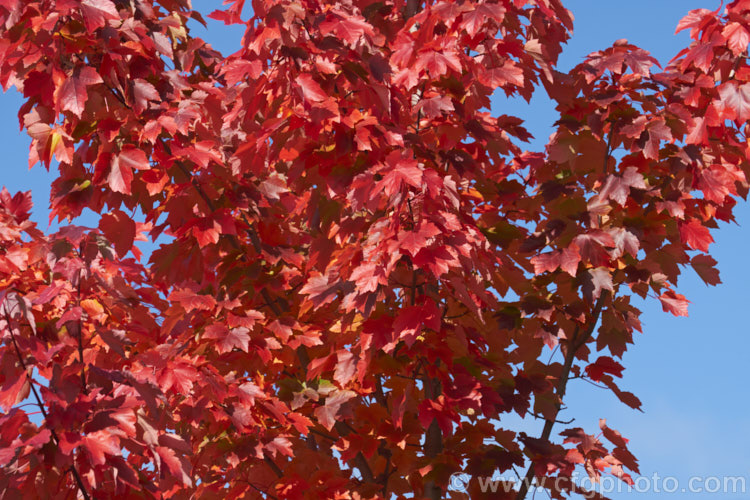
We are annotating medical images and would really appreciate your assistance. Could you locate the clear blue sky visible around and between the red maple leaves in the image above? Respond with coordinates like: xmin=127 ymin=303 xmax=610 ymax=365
xmin=0 ymin=0 xmax=750 ymax=500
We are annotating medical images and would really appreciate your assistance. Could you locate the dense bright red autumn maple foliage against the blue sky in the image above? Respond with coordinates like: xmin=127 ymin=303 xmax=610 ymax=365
xmin=0 ymin=0 xmax=750 ymax=499
